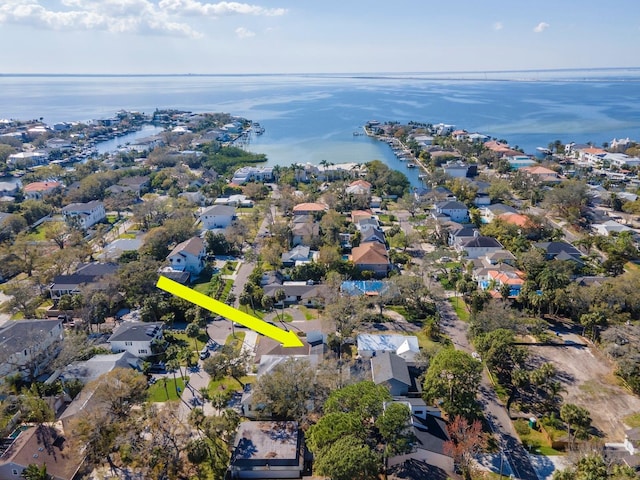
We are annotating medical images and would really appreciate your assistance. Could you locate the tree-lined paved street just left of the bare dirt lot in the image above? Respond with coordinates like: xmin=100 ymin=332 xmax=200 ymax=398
xmin=438 ymin=301 xmax=538 ymax=480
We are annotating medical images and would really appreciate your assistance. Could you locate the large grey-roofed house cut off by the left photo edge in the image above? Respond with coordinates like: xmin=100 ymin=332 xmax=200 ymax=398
xmin=0 ymin=319 xmax=64 ymax=384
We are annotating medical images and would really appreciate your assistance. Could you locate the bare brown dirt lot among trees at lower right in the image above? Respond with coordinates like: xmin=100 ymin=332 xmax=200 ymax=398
xmin=530 ymin=334 xmax=640 ymax=442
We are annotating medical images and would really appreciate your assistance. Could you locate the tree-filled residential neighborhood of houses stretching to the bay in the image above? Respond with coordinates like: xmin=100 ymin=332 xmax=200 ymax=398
xmin=0 ymin=110 xmax=640 ymax=480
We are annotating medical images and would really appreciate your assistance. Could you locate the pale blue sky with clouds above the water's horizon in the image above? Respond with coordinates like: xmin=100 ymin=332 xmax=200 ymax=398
xmin=0 ymin=0 xmax=640 ymax=74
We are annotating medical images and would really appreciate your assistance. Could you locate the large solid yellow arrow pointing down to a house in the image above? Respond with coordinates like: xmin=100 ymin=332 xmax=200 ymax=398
xmin=156 ymin=276 xmax=303 ymax=347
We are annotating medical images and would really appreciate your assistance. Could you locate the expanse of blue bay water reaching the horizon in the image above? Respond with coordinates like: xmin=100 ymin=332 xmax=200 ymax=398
xmin=0 ymin=67 xmax=640 ymax=185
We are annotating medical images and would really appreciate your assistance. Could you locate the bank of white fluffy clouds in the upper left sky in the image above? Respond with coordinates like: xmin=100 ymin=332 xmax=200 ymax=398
xmin=0 ymin=0 xmax=286 ymax=38
